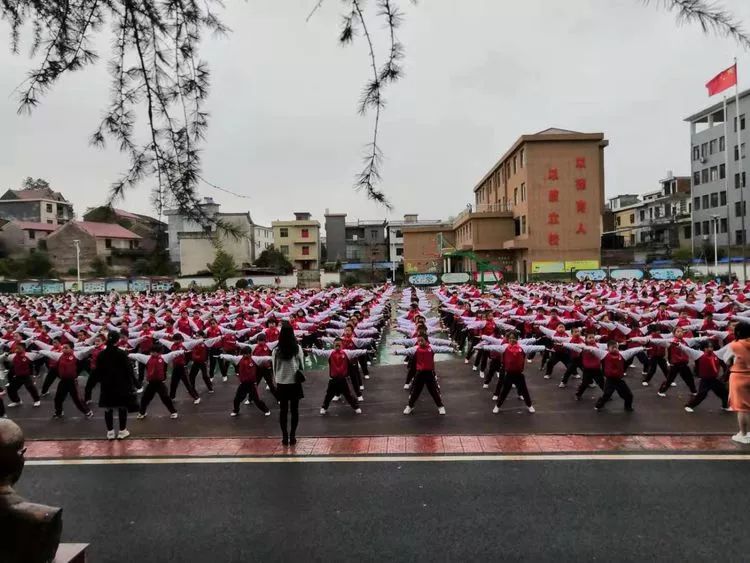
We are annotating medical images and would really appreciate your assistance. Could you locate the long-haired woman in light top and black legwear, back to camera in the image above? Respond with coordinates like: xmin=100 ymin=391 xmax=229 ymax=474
xmin=272 ymin=322 xmax=305 ymax=446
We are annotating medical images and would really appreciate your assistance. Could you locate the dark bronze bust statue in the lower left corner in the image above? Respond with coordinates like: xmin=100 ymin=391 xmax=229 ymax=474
xmin=0 ymin=419 xmax=62 ymax=563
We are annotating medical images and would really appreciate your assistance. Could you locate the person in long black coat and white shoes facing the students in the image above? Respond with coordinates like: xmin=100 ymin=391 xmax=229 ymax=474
xmin=96 ymin=332 xmax=138 ymax=440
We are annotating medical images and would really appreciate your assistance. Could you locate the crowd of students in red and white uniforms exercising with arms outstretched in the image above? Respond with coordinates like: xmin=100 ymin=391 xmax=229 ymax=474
xmin=0 ymin=281 xmax=750 ymax=443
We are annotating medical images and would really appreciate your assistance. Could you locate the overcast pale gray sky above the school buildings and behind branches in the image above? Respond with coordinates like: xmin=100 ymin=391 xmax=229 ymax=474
xmin=0 ymin=0 xmax=750 ymax=228
